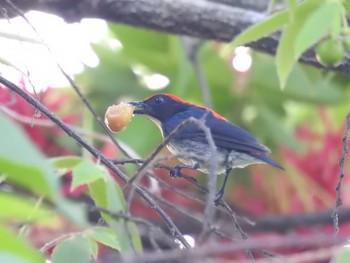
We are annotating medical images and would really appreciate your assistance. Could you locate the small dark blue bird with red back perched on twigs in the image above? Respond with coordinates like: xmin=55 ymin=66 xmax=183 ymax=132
xmin=129 ymin=94 xmax=283 ymax=205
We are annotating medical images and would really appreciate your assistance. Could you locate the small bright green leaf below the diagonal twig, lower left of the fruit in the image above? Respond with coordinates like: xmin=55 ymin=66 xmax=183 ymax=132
xmin=71 ymin=159 xmax=106 ymax=189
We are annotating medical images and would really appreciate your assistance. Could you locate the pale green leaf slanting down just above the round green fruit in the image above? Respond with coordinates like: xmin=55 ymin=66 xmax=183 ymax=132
xmin=294 ymin=2 xmax=341 ymax=59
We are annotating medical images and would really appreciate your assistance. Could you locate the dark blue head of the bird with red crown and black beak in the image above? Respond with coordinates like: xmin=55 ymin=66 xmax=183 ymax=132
xmin=129 ymin=94 xmax=189 ymax=122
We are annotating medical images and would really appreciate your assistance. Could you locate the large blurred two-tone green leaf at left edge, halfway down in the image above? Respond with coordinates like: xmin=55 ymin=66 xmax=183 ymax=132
xmin=0 ymin=114 xmax=59 ymax=200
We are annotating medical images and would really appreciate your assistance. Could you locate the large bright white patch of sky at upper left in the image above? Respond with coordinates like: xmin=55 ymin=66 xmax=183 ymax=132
xmin=0 ymin=11 xmax=108 ymax=91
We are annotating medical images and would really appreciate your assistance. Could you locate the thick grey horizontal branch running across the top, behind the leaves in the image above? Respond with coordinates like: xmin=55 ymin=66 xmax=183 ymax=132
xmin=4 ymin=0 xmax=350 ymax=76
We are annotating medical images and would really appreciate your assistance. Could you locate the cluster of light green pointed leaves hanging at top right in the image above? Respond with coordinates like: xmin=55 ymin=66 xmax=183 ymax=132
xmin=232 ymin=0 xmax=348 ymax=88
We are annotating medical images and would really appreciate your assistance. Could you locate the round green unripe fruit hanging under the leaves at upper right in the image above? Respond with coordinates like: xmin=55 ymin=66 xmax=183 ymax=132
xmin=316 ymin=38 xmax=345 ymax=67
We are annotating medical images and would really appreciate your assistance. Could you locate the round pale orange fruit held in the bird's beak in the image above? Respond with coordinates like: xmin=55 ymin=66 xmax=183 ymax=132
xmin=105 ymin=102 xmax=134 ymax=132
